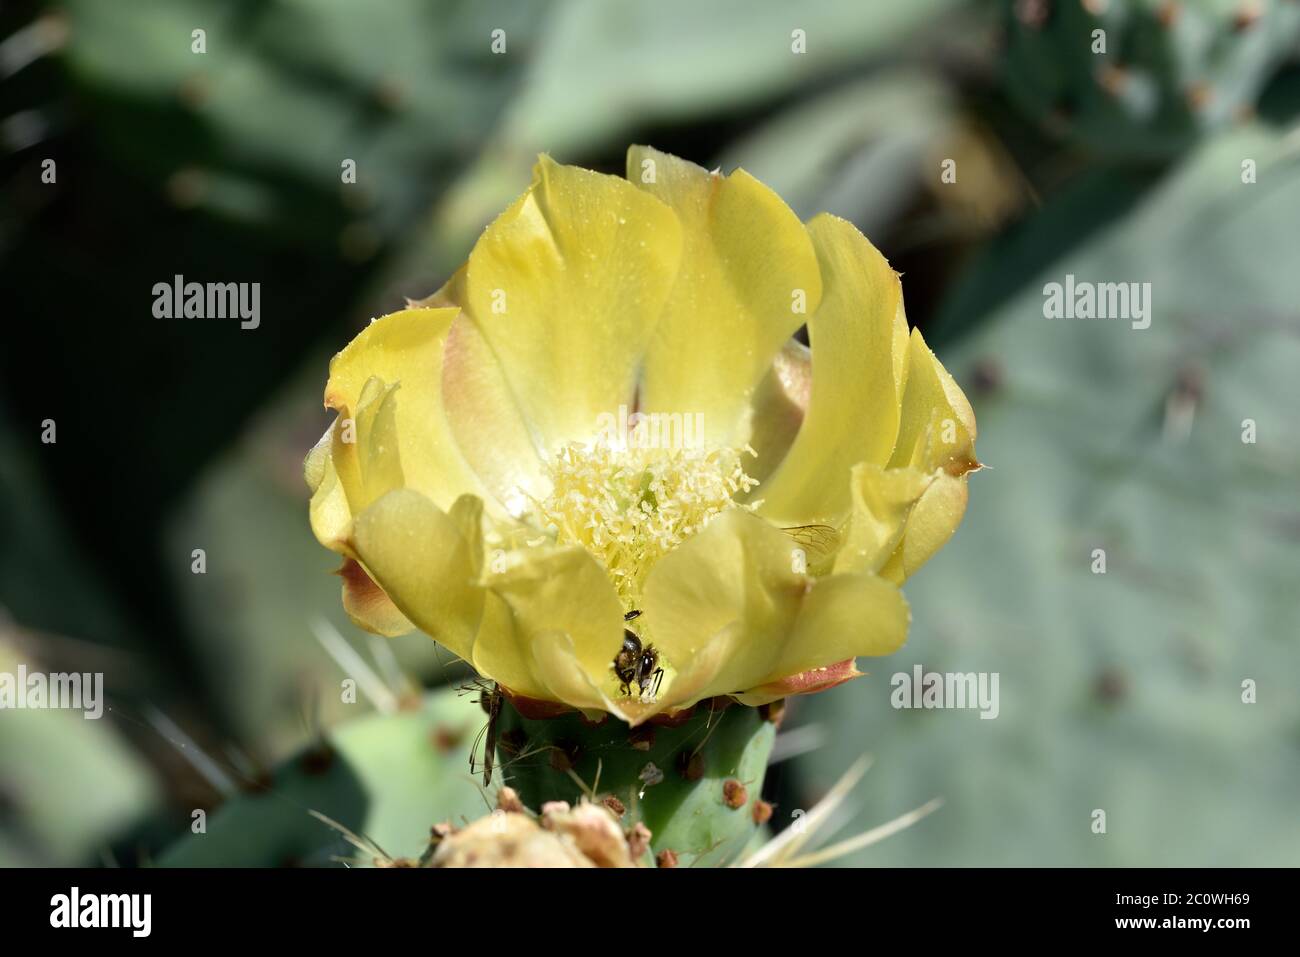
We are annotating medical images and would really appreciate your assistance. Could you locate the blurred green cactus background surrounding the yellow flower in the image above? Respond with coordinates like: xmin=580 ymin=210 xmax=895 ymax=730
xmin=0 ymin=0 xmax=1300 ymax=865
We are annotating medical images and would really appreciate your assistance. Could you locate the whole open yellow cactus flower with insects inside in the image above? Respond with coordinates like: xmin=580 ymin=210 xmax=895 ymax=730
xmin=306 ymin=147 xmax=979 ymax=724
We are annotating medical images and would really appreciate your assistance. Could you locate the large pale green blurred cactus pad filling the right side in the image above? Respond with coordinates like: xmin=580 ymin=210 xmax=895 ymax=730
xmin=800 ymin=127 xmax=1300 ymax=867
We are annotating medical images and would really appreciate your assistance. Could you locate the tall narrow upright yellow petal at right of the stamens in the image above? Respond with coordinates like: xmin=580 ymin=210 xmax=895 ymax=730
xmin=754 ymin=213 xmax=907 ymax=525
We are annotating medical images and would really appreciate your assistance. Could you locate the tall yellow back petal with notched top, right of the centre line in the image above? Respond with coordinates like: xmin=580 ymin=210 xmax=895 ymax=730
xmin=628 ymin=147 xmax=822 ymax=447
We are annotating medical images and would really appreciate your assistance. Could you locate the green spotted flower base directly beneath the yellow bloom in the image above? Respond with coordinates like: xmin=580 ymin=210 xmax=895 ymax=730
xmin=498 ymin=702 xmax=776 ymax=866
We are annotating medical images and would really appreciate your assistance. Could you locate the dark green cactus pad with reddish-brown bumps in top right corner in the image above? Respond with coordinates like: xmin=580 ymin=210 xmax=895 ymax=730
xmin=1002 ymin=0 xmax=1300 ymax=160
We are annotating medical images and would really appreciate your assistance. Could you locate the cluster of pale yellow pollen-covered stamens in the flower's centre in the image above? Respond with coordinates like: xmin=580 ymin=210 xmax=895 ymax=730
xmin=536 ymin=438 xmax=758 ymax=600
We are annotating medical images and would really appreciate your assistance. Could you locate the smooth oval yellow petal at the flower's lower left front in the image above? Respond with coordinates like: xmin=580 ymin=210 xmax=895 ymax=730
xmin=354 ymin=489 xmax=484 ymax=661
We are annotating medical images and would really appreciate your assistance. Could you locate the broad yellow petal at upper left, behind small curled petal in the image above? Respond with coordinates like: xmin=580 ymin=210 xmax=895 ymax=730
xmin=325 ymin=308 xmax=485 ymax=512
